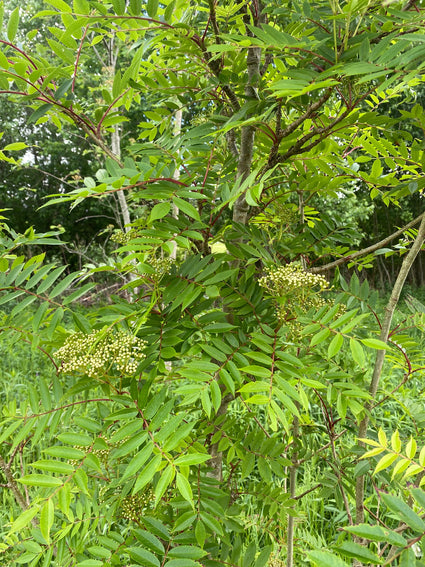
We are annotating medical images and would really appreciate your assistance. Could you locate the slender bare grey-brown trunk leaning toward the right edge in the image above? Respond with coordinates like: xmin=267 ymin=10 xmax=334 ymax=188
xmin=356 ymin=216 xmax=425 ymax=540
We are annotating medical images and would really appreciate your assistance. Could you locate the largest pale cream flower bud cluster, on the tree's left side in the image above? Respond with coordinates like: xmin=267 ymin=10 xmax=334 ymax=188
xmin=56 ymin=329 xmax=146 ymax=378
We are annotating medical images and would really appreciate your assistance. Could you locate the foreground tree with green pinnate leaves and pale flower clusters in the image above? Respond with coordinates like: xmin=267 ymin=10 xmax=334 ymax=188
xmin=0 ymin=0 xmax=425 ymax=567
